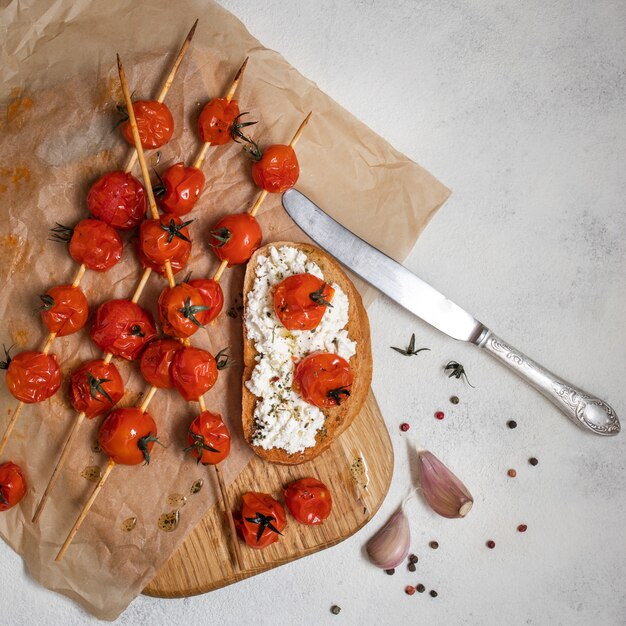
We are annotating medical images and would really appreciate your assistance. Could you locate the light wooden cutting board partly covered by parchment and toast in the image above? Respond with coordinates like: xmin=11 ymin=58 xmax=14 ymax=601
xmin=144 ymin=390 xmax=393 ymax=598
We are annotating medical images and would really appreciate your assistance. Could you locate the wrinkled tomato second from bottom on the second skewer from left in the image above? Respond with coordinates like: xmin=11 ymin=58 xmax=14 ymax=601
xmin=91 ymin=300 xmax=156 ymax=361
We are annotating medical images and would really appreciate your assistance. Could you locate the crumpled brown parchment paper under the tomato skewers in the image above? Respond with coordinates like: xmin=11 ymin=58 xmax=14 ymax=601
xmin=0 ymin=0 xmax=449 ymax=619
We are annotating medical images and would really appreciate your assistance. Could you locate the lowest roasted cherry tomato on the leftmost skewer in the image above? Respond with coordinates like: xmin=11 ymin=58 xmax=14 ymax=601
xmin=0 ymin=349 xmax=61 ymax=404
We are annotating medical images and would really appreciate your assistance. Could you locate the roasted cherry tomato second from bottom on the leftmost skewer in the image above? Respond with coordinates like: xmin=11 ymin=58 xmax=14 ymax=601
xmin=39 ymin=285 xmax=89 ymax=337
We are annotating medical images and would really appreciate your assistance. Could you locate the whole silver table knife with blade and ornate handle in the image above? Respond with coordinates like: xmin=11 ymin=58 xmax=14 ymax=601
xmin=283 ymin=189 xmax=620 ymax=436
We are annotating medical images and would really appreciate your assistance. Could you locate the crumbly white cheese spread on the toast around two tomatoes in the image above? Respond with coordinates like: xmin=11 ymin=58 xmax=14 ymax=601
xmin=245 ymin=246 xmax=356 ymax=454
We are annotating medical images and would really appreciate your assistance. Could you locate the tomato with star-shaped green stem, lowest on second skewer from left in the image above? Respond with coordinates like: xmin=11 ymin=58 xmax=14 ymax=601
xmin=68 ymin=359 xmax=124 ymax=419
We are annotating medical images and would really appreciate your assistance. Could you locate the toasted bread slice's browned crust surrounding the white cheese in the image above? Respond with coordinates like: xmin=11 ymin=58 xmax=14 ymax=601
xmin=241 ymin=241 xmax=372 ymax=465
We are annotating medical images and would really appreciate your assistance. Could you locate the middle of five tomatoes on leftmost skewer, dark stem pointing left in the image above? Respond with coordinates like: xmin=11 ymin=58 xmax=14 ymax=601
xmin=52 ymin=219 xmax=122 ymax=272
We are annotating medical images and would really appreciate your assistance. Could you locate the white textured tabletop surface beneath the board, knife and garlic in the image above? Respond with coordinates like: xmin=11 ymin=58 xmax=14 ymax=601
xmin=0 ymin=0 xmax=626 ymax=626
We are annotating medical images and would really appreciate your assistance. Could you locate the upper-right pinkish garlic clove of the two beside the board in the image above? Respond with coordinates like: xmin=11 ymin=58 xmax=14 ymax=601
xmin=417 ymin=450 xmax=474 ymax=519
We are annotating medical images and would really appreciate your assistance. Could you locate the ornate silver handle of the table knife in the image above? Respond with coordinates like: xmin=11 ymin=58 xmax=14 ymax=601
xmin=476 ymin=329 xmax=620 ymax=436
